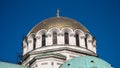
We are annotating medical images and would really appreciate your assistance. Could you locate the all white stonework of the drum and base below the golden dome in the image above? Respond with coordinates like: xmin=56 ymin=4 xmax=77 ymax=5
xmin=22 ymin=27 xmax=96 ymax=68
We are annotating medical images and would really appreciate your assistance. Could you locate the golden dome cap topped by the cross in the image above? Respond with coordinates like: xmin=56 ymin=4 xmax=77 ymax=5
xmin=29 ymin=17 xmax=89 ymax=34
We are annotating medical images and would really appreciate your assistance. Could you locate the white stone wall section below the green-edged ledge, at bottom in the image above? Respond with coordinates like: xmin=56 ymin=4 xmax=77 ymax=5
xmin=30 ymin=58 xmax=64 ymax=68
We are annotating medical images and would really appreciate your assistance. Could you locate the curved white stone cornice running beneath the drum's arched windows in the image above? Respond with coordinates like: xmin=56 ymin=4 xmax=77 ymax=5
xmin=30 ymin=45 xmax=97 ymax=56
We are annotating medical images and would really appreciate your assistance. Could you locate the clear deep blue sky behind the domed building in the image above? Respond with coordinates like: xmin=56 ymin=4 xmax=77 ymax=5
xmin=0 ymin=0 xmax=120 ymax=68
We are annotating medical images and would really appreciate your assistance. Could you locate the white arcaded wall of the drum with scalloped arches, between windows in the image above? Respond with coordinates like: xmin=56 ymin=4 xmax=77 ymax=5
xmin=23 ymin=27 xmax=96 ymax=55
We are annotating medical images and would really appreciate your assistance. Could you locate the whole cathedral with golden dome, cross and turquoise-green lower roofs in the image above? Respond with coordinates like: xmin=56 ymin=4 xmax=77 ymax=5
xmin=0 ymin=10 xmax=113 ymax=68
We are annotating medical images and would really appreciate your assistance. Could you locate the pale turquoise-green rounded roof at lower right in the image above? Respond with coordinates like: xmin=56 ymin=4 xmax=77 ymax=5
xmin=60 ymin=56 xmax=112 ymax=68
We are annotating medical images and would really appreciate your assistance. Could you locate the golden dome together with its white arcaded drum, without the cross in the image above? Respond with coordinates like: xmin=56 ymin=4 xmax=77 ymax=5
xmin=22 ymin=16 xmax=97 ymax=66
